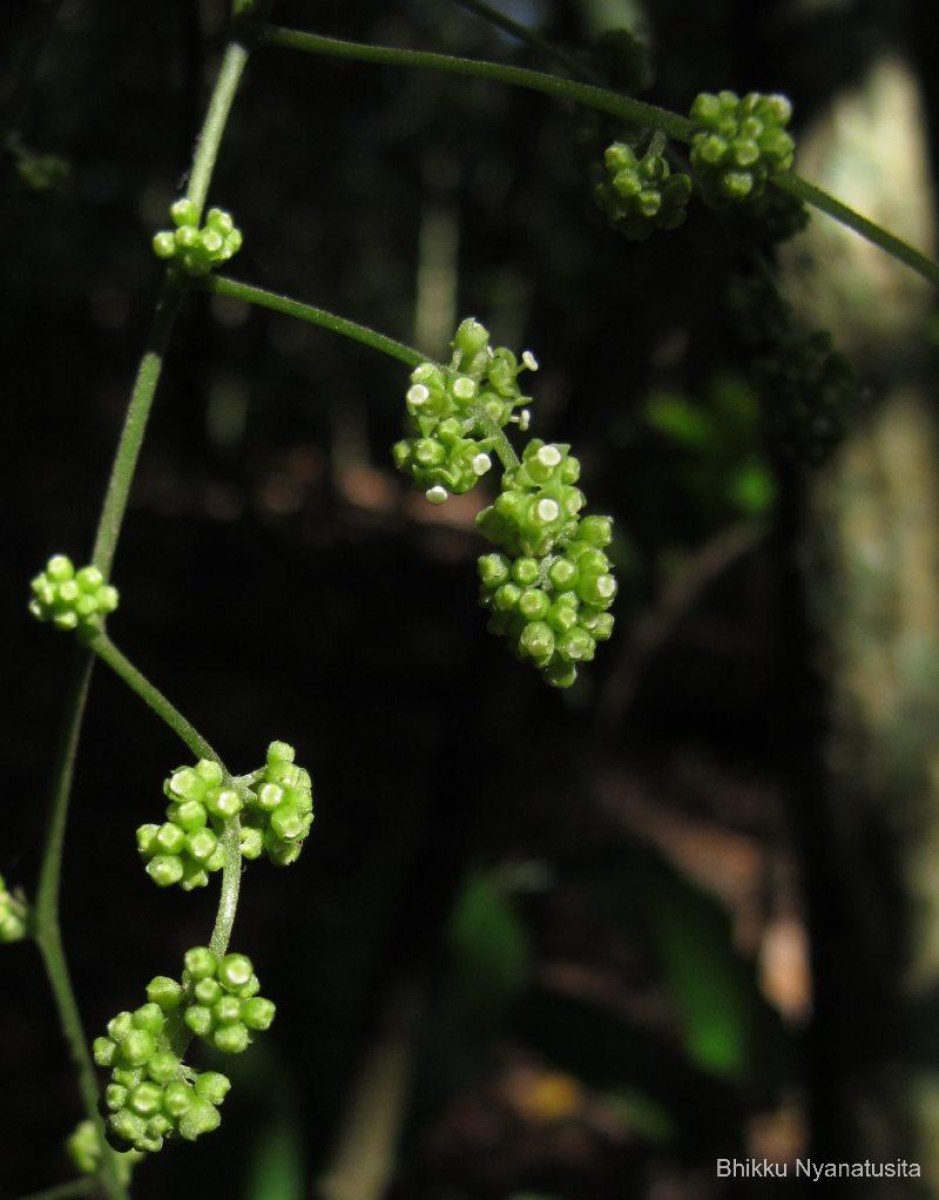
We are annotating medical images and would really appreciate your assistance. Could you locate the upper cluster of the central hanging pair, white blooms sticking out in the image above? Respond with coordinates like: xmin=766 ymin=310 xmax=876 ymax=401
xmin=391 ymin=317 xmax=538 ymax=504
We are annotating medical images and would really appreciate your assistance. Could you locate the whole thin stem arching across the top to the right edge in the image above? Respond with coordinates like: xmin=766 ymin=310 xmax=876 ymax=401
xmin=258 ymin=21 xmax=939 ymax=287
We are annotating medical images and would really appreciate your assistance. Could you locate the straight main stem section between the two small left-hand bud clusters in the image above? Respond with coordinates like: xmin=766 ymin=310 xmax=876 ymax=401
xmin=91 ymin=277 xmax=183 ymax=578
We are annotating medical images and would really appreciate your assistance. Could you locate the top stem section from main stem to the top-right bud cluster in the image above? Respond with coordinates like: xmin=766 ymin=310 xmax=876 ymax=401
xmin=258 ymin=25 xmax=696 ymax=142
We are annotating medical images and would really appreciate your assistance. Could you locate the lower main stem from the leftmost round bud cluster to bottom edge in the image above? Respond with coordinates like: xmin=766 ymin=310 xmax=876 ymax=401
xmin=32 ymin=647 xmax=127 ymax=1200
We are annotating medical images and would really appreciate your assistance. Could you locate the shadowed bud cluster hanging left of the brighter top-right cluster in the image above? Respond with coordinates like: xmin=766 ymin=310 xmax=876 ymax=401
xmin=593 ymin=131 xmax=692 ymax=241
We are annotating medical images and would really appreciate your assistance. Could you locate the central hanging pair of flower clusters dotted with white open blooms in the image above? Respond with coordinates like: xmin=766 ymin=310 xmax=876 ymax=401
xmin=394 ymin=318 xmax=616 ymax=688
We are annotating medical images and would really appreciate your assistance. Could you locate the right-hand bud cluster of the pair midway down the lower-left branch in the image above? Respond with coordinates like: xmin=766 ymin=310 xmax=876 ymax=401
xmin=241 ymin=742 xmax=313 ymax=866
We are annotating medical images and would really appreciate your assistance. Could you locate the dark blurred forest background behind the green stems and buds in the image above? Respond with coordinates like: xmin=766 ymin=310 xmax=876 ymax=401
xmin=0 ymin=0 xmax=935 ymax=1200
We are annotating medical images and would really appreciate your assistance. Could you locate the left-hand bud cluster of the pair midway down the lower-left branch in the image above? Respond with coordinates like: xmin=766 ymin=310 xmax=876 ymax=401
xmin=137 ymin=758 xmax=244 ymax=892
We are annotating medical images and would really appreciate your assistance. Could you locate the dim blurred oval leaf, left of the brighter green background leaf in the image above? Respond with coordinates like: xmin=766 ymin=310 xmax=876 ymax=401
xmin=447 ymin=870 xmax=532 ymax=1024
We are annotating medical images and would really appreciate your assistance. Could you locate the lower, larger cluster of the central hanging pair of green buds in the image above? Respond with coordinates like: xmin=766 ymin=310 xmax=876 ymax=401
xmin=477 ymin=438 xmax=616 ymax=688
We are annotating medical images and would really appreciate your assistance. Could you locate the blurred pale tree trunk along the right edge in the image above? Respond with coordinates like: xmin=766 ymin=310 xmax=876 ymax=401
xmin=785 ymin=56 xmax=939 ymax=1198
